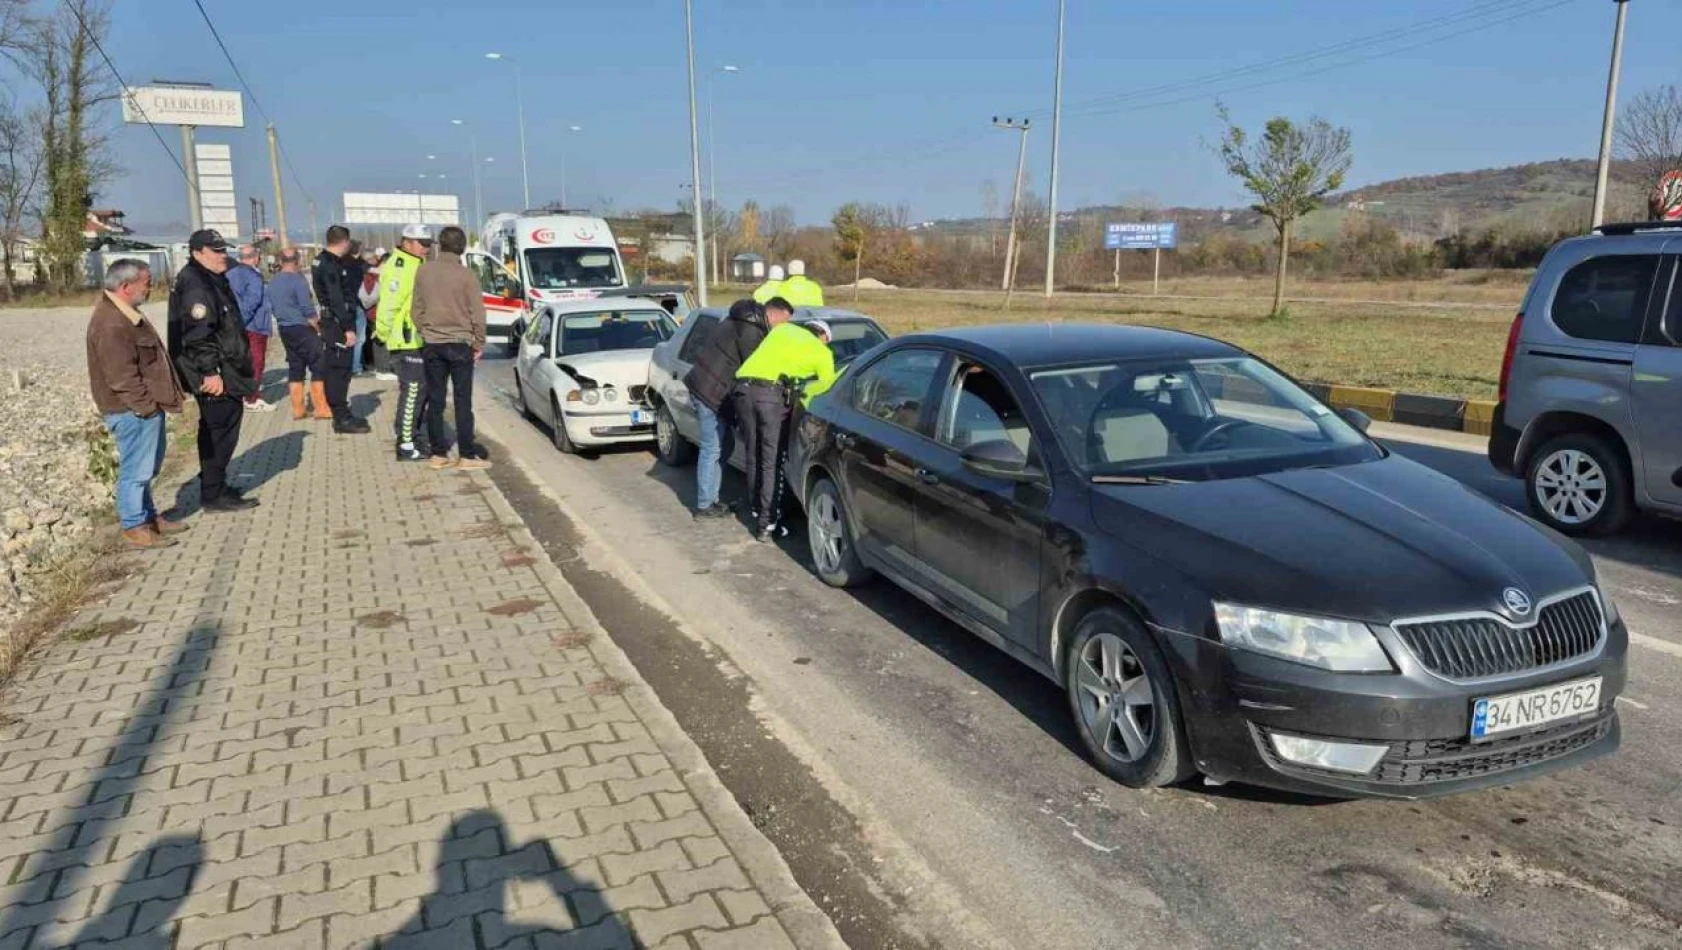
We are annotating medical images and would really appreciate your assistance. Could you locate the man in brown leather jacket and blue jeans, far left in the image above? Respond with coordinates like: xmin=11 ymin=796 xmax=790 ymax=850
xmin=87 ymin=261 xmax=185 ymax=548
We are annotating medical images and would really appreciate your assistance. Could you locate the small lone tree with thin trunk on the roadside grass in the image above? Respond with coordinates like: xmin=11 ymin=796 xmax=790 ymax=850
xmin=1216 ymin=106 xmax=1354 ymax=316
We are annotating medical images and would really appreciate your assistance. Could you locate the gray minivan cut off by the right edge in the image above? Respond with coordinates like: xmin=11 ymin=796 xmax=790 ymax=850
xmin=1489 ymin=222 xmax=1682 ymax=535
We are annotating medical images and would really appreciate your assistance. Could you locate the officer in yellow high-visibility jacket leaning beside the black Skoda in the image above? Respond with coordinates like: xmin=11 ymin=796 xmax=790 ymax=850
xmin=732 ymin=298 xmax=836 ymax=541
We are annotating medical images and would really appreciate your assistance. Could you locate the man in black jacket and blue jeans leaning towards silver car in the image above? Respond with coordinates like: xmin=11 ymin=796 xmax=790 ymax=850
xmin=683 ymin=299 xmax=770 ymax=518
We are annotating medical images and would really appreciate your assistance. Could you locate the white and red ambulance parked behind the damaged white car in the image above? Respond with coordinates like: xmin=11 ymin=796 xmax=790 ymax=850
xmin=468 ymin=214 xmax=626 ymax=350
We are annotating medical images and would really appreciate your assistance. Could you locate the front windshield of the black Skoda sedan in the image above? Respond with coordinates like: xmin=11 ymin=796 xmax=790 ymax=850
xmin=1029 ymin=356 xmax=1383 ymax=481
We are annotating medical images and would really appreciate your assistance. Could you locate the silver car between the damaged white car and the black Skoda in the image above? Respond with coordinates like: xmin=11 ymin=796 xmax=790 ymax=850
xmin=648 ymin=306 xmax=888 ymax=469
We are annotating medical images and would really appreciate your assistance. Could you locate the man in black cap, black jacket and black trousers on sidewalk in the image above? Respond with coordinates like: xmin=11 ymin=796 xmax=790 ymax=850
xmin=170 ymin=230 xmax=257 ymax=511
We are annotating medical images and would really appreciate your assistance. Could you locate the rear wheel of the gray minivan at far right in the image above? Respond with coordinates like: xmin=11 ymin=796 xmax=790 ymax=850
xmin=1524 ymin=432 xmax=1633 ymax=538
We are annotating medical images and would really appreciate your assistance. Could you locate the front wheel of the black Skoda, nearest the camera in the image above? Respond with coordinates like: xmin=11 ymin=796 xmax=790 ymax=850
xmin=1063 ymin=607 xmax=1196 ymax=789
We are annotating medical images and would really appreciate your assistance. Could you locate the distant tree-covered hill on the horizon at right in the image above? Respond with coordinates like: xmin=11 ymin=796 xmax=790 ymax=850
xmin=920 ymin=158 xmax=1645 ymax=242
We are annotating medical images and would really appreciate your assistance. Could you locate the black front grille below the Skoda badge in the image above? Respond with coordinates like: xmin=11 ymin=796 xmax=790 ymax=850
xmin=1394 ymin=590 xmax=1605 ymax=679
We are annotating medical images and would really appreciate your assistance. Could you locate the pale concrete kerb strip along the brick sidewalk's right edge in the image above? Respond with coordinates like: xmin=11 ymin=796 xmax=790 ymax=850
xmin=481 ymin=415 xmax=846 ymax=950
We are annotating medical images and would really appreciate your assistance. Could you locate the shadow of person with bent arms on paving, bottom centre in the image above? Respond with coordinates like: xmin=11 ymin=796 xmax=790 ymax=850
xmin=380 ymin=809 xmax=644 ymax=950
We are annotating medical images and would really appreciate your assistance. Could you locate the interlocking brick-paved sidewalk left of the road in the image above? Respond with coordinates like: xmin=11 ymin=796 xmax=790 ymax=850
xmin=0 ymin=383 xmax=839 ymax=950
